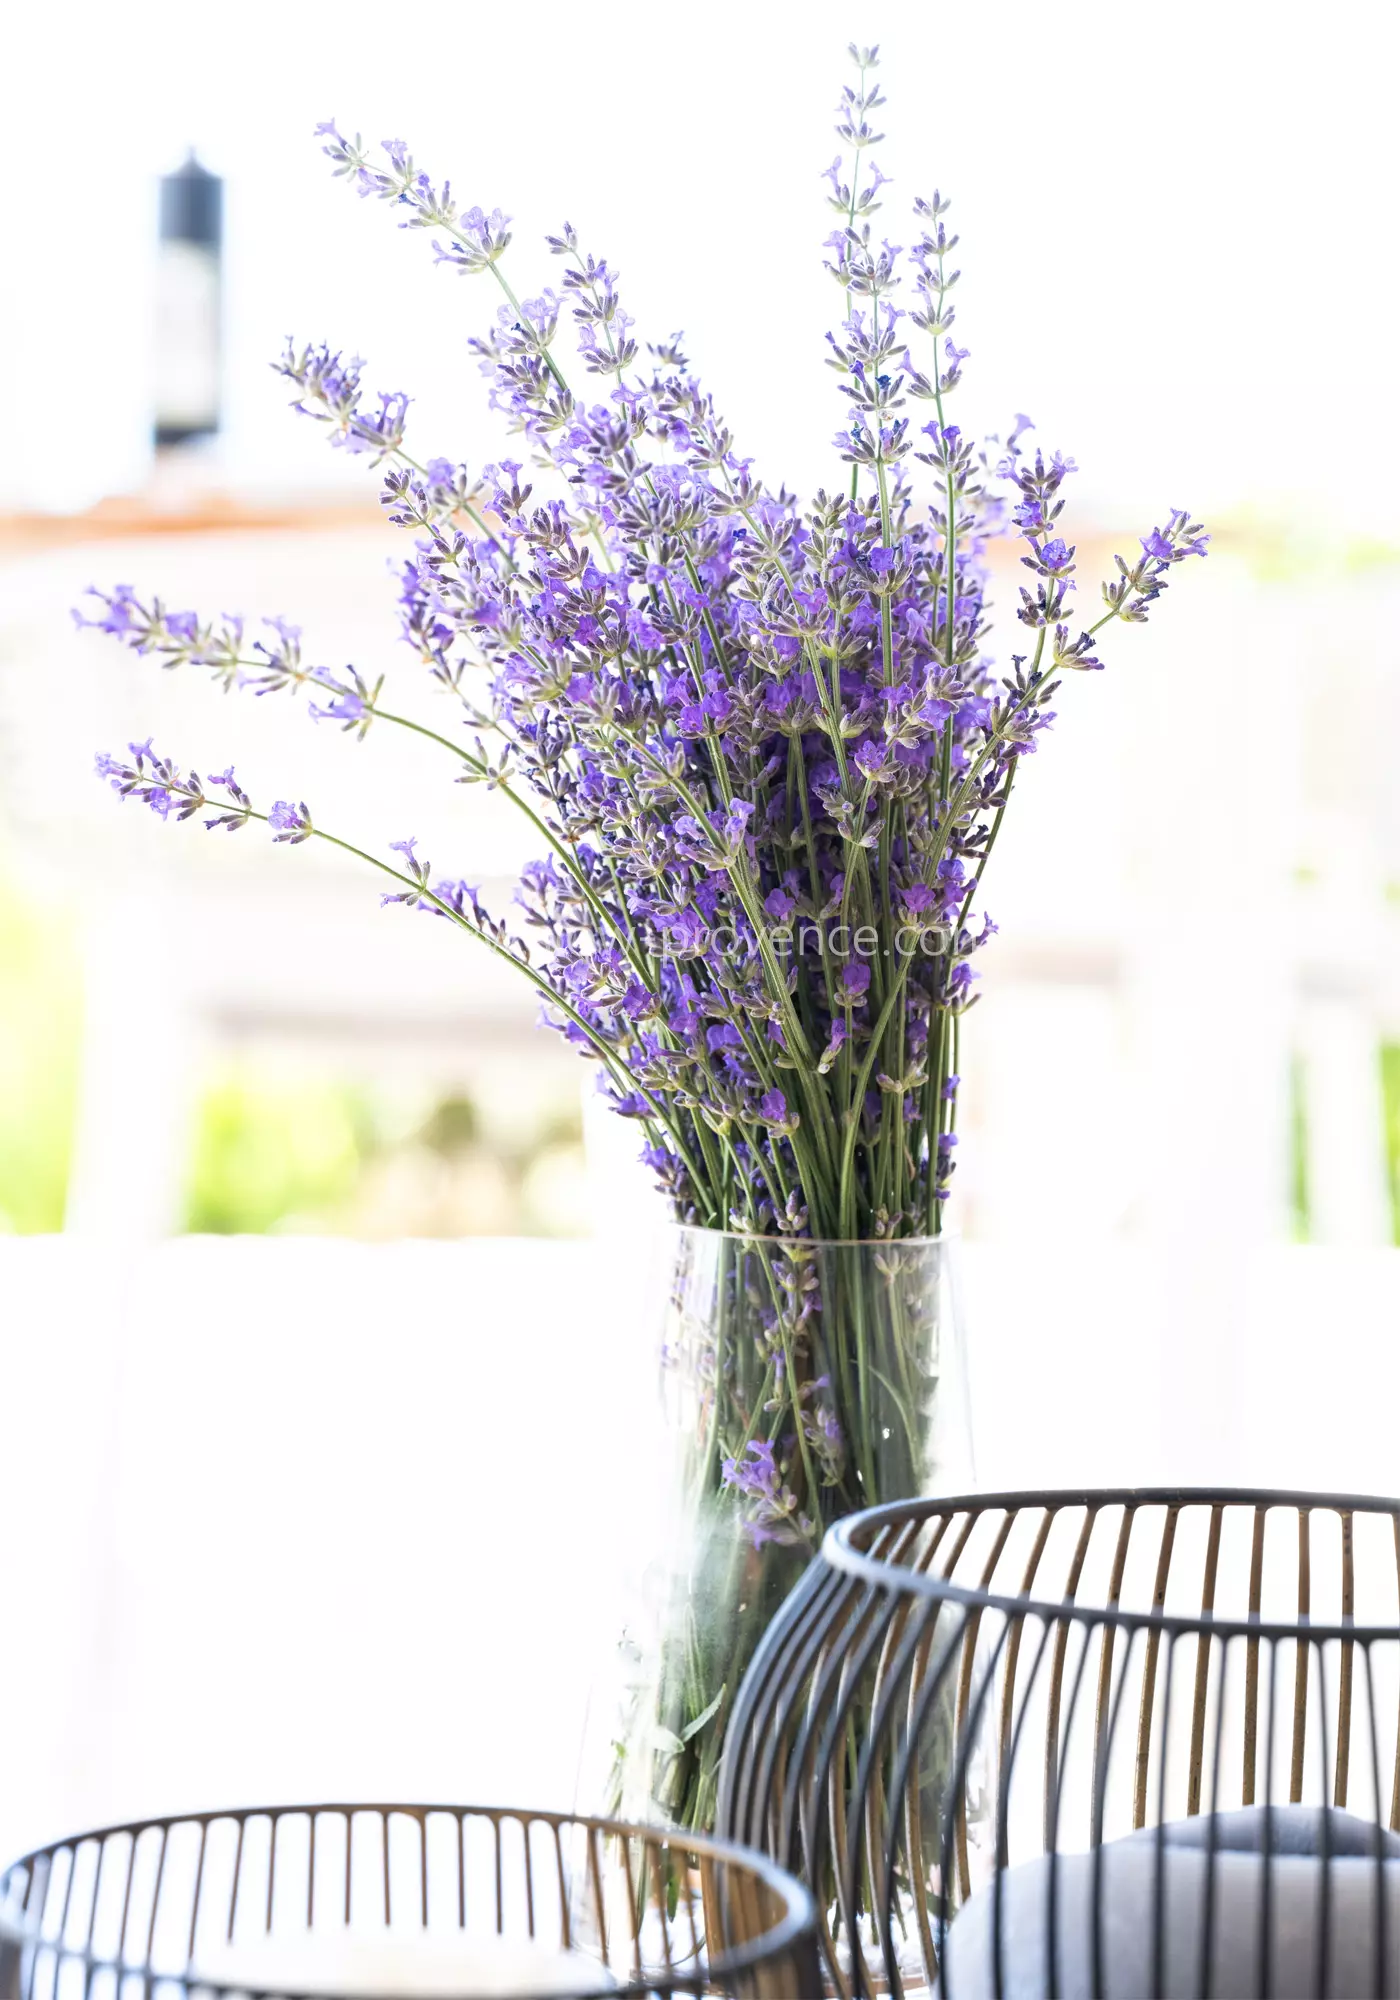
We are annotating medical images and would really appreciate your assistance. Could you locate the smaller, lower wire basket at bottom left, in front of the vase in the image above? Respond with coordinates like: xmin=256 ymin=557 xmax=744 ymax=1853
xmin=0 ymin=1804 xmax=822 ymax=2000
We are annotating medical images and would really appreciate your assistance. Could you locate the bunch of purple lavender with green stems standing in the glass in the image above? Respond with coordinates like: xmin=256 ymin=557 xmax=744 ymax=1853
xmin=86 ymin=48 xmax=1206 ymax=1822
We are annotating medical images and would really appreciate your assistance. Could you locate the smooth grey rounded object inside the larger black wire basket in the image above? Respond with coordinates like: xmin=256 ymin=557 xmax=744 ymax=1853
xmin=942 ymin=1806 xmax=1400 ymax=2000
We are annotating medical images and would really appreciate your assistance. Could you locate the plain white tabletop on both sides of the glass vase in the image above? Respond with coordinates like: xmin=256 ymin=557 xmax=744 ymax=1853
xmin=0 ymin=1238 xmax=1400 ymax=1854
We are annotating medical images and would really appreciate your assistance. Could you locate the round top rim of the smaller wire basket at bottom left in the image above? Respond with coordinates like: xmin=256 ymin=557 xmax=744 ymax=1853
xmin=0 ymin=1798 xmax=818 ymax=2000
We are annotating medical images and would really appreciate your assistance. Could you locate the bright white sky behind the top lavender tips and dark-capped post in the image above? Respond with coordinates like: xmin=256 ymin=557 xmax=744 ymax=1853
xmin=0 ymin=0 xmax=1400 ymax=538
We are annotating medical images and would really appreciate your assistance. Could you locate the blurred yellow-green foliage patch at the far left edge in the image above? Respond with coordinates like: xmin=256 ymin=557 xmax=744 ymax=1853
xmin=0 ymin=868 xmax=82 ymax=1236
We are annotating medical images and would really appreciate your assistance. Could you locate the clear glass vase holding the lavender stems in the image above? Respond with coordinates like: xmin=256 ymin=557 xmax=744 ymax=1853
xmin=608 ymin=1228 xmax=972 ymax=1830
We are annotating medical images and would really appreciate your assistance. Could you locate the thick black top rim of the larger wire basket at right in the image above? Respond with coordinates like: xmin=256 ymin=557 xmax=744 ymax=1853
xmin=822 ymin=1486 xmax=1400 ymax=1646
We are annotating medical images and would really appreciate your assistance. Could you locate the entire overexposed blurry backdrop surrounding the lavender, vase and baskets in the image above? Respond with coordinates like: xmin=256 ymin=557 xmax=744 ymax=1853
xmin=0 ymin=0 xmax=1400 ymax=1872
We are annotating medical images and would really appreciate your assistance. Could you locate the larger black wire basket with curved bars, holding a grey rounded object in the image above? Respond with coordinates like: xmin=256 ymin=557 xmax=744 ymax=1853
xmin=718 ymin=1490 xmax=1400 ymax=2000
